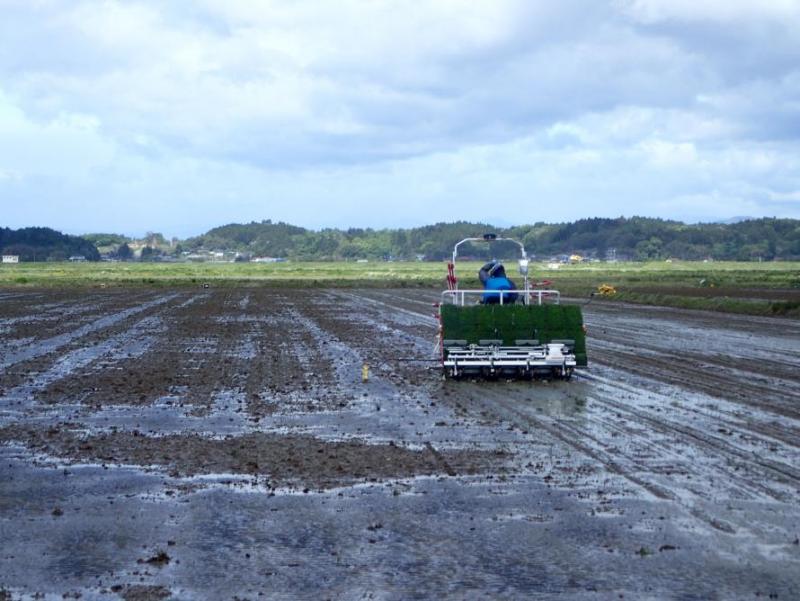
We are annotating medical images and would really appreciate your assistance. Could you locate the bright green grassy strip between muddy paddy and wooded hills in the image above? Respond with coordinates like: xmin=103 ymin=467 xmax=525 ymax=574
xmin=0 ymin=261 xmax=800 ymax=316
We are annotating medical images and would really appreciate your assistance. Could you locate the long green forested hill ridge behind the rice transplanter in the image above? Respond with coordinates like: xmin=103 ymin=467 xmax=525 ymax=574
xmin=188 ymin=217 xmax=800 ymax=261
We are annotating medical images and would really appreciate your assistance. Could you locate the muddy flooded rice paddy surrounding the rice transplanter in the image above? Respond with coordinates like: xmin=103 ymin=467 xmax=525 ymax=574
xmin=0 ymin=288 xmax=800 ymax=600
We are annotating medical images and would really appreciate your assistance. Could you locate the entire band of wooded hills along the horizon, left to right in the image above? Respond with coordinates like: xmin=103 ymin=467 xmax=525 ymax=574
xmin=0 ymin=217 xmax=800 ymax=261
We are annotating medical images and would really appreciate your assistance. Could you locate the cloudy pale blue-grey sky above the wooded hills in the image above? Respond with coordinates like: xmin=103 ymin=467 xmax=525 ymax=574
xmin=0 ymin=0 xmax=800 ymax=237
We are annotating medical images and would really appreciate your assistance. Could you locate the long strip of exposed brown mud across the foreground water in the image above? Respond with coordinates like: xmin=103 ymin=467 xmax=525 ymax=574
xmin=0 ymin=426 xmax=506 ymax=489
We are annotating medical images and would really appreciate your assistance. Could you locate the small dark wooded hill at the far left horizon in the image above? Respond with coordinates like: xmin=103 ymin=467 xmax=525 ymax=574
xmin=0 ymin=227 xmax=100 ymax=261
